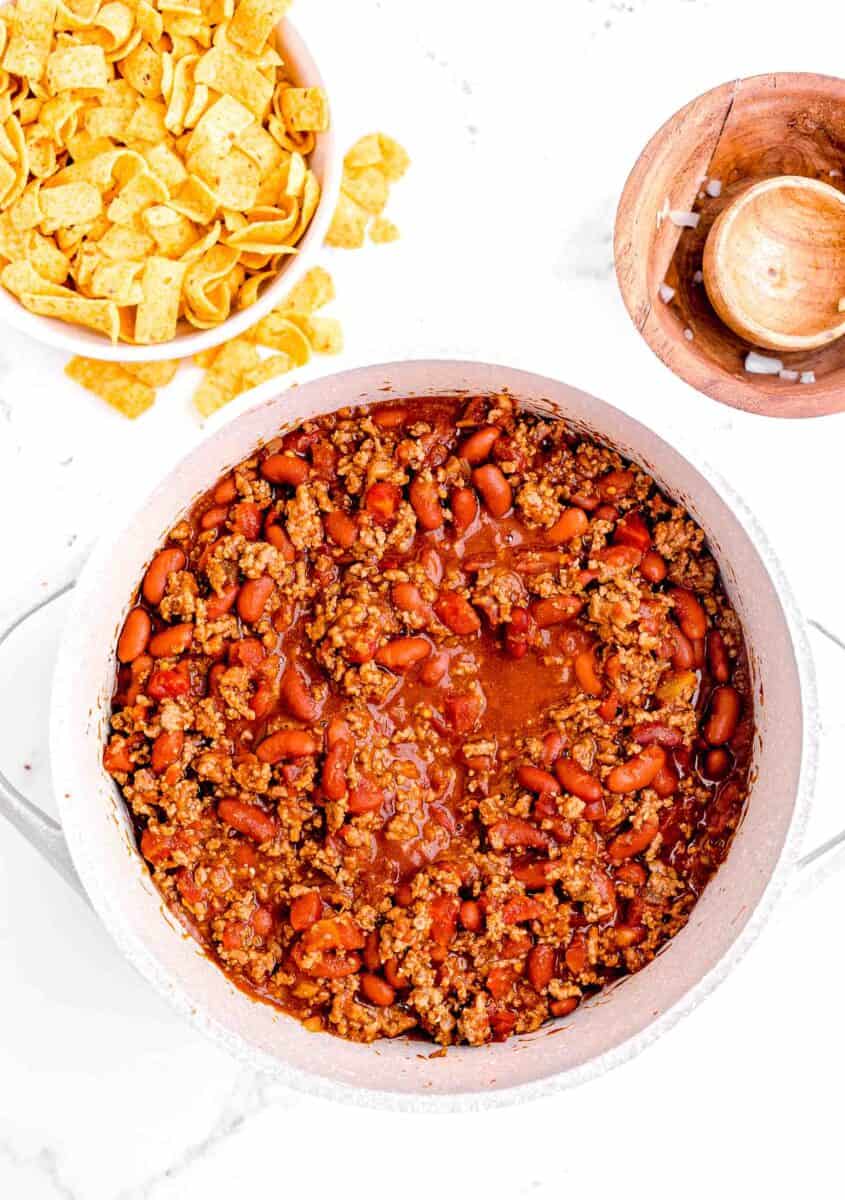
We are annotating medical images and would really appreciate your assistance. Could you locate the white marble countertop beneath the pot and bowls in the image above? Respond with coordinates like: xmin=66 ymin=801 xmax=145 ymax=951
xmin=0 ymin=0 xmax=845 ymax=1200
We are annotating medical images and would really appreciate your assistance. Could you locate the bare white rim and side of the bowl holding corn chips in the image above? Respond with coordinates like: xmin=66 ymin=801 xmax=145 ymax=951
xmin=0 ymin=19 xmax=340 ymax=362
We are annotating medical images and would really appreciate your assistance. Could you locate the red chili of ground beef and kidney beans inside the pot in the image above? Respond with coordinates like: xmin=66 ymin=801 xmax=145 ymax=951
xmin=104 ymin=396 xmax=753 ymax=1045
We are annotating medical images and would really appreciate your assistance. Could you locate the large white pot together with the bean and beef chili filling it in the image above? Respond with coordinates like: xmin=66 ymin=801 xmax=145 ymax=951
xmin=4 ymin=360 xmax=816 ymax=1109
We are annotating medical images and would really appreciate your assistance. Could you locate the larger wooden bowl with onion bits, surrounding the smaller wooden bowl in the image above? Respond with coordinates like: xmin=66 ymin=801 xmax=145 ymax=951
xmin=615 ymin=73 xmax=845 ymax=416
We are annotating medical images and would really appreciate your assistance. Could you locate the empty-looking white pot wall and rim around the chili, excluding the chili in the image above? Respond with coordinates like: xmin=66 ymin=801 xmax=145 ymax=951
xmin=0 ymin=361 xmax=816 ymax=1109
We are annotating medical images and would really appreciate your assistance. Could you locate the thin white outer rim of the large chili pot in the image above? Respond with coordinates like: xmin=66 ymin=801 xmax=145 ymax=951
xmin=49 ymin=358 xmax=819 ymax=1112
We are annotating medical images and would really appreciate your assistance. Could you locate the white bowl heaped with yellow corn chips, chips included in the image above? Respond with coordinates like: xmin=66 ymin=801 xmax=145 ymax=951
xmin=0 ymin=0 xmax=340 ymax=362
